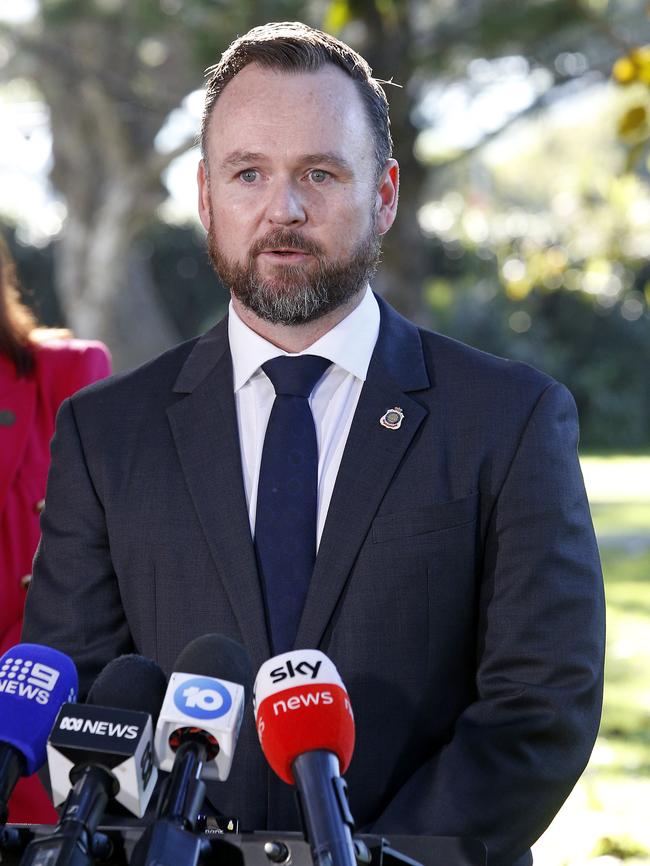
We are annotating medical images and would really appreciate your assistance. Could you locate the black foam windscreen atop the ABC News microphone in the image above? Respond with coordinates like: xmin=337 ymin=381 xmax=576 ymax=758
xmin=86 ymin=653 xmax=167 ymax=727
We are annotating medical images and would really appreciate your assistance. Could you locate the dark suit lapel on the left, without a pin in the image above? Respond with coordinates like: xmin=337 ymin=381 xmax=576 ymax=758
xmin=167 ymin=319 xmax=270 ymax=667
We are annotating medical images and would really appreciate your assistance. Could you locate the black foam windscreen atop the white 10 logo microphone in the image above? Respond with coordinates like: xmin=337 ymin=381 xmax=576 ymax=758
xmin=174 ymin=634 xmax=253 ymax=700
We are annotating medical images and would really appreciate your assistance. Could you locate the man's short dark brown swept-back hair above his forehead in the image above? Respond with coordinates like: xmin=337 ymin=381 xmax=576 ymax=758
xmin=201 ymin=21 xmax=393 ymax=174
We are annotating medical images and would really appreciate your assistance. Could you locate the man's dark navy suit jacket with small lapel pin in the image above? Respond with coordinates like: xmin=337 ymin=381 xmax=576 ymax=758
xmin=23 ymin=294 xmax=604 ymax=866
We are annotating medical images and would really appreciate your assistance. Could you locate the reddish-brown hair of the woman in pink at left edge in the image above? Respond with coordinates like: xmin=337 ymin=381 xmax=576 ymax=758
xmin=0 ymin=236 xmax=36 ymax=376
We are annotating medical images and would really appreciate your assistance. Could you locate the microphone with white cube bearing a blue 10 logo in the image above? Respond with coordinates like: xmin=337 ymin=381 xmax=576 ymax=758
xmin=130 ymin=634 xmax=253 ymax=866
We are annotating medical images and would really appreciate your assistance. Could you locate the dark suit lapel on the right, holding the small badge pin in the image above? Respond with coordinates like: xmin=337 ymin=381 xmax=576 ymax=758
xmin=296 ymin=300 xmax=430 ymax=647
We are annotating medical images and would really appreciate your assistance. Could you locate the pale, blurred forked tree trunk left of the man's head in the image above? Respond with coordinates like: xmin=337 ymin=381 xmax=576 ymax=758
xmin=8 ymin=13 xmax=193 ymax=370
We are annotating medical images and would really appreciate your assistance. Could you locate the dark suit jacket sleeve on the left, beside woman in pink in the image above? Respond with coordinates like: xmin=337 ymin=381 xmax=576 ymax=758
xmin=22 ymin=399 xmax=133 ymax=697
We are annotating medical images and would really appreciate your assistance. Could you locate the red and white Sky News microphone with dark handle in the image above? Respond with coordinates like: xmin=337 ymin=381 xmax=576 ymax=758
xmin=253 ymin=650 xmax=357 ymax=866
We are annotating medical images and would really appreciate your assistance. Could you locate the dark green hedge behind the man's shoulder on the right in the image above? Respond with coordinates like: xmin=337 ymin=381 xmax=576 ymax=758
xmin=416 ymin=238 xmax=650 ymax=449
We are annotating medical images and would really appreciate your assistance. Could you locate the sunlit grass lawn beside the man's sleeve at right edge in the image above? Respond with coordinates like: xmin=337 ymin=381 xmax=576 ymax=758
xmin=534 ymin=455 xmax=650 ymax=866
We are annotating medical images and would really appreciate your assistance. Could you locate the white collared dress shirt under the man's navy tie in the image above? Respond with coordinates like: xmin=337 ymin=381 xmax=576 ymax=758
xmin=228 ymin=288 xmax=380 ymax=545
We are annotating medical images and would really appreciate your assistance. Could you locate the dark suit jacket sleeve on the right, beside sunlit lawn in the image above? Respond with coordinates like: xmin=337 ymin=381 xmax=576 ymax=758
xmin=372 ymin=383 xmax=604 ymax=866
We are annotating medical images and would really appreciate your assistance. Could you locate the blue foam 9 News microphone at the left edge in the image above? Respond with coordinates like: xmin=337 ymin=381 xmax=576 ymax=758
xmin=0 ymin=643 xmax=78 ymax=826
